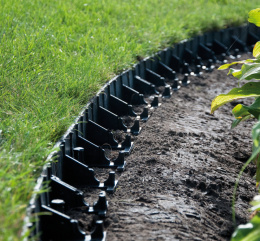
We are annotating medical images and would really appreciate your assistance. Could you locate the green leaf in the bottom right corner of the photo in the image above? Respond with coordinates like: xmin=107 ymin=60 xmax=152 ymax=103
xmin=231 ymin=214 xmax=260 ymax=241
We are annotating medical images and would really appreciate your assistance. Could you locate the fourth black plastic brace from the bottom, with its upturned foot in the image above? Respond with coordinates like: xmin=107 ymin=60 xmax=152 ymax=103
xmin=76 ymin=136 xmax=125 ymax=171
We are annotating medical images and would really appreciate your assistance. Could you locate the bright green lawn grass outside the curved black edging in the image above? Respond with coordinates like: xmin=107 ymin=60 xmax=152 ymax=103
xmin=0 ymin=0 xmax=258 ymax=241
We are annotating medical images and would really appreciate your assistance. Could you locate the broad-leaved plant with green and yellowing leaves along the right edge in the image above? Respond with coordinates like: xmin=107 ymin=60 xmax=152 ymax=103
xmin=211 ymin=8 xmax=260 ymax=241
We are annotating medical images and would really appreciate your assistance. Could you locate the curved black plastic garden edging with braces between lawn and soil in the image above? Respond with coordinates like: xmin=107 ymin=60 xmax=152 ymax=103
xmin=24 ymin=25 xmax=260 ymax=241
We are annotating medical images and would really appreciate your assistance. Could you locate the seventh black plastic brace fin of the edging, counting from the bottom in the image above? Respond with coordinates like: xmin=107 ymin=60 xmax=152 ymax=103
xmin=108 ymin=95 xmax=137 ymax=117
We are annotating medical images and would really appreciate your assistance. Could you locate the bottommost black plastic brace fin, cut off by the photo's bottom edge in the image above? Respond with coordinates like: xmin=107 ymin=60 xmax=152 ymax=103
xmin=39 ymin=205 xmax=86 ymax=241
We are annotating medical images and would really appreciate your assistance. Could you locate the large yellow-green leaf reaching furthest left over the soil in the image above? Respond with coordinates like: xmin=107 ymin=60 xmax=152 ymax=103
xmin=211 ymin=82 xmax=260 ymax=113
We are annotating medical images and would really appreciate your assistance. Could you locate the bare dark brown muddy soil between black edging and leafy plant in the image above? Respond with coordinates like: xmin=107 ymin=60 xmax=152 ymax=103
xmin=68 ymin=55 xmax=256 ymax=241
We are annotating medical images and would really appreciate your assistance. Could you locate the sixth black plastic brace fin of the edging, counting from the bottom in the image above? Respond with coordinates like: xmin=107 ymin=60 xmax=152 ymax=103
xmin=97 ymin=106 xmax=127 ymax=131
